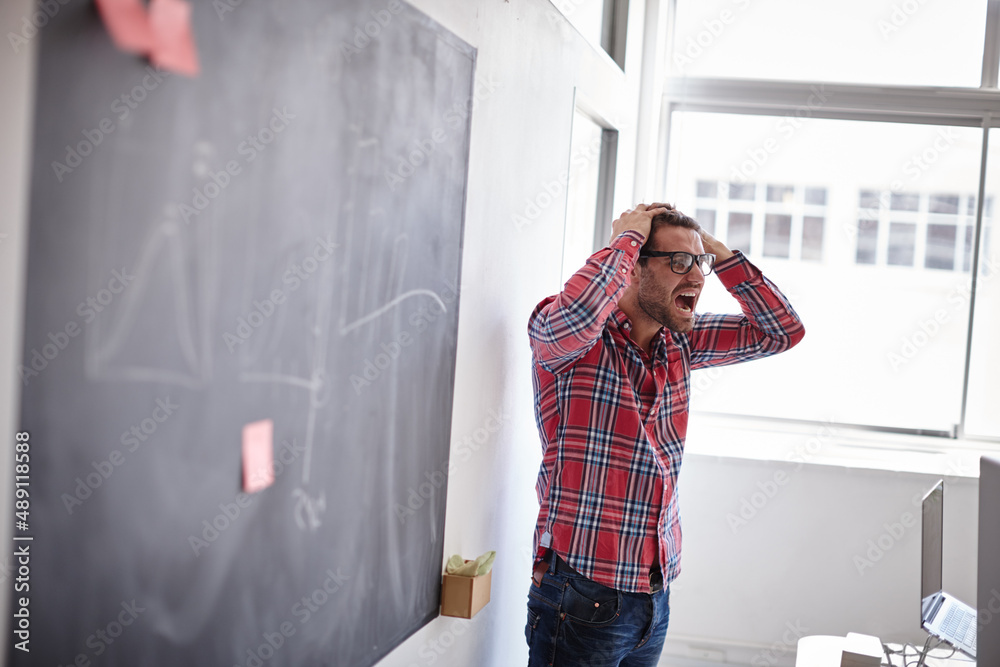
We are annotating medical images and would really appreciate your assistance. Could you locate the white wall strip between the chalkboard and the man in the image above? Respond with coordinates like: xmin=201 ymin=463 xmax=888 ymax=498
xmin=379 ymin=0 xmax=644 ymax=667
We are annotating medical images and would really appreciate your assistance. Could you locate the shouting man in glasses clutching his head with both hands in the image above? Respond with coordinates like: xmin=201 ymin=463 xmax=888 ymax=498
xmin=525 ymin=204 xmax=805 ymax=667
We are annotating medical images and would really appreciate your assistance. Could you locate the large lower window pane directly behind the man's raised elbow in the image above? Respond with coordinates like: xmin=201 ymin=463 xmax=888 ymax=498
xmin=665 ymin=111 xmax=984 ymax=432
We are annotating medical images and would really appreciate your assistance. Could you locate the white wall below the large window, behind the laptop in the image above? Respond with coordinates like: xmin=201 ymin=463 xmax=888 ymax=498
xmin=661 ymin=444 xmax=978 ymax=667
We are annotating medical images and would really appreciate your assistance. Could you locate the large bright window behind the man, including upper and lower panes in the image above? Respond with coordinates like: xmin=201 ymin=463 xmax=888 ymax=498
xmin=662 ymin=0 xmax=1000 ymax=442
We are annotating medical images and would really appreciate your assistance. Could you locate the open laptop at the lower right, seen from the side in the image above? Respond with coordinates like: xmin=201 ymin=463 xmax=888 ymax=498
xmin=920 ymin=480 xmax=977 ymax=658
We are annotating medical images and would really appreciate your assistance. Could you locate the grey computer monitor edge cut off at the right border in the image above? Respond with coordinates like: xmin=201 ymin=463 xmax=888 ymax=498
xmin=976 ymin=456 xmax=1000 ymax=667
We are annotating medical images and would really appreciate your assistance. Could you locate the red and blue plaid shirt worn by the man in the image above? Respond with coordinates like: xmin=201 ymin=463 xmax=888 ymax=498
xmin=528 ymin=231 xmax=805 ymax=593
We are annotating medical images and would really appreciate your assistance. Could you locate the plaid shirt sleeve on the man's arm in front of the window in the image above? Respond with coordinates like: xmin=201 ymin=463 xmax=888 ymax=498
xmin=689 ymin=250 xmax=806 ymax=370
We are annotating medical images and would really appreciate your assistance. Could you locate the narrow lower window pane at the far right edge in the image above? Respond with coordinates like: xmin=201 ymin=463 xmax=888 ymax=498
xmin=960 ymin=130 xmax=1000 ymax=438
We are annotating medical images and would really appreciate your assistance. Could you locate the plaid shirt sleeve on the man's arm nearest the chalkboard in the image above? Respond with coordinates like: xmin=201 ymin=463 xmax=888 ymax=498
xmin=528 ymin=231 xmax=643 ymax=373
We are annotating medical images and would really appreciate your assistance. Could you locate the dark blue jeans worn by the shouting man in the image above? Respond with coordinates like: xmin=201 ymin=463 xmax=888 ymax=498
xmin=524 ymin=567 xmax=670 ymax=667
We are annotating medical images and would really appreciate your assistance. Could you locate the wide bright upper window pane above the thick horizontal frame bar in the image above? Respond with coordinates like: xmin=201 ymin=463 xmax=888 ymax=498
xmin=670 ymin=0 xmax=987 ymax=87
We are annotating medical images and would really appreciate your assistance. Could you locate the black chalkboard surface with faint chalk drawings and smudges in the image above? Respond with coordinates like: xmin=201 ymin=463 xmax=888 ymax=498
xmin=10 ymin=0 xmax=475 ymax=667
